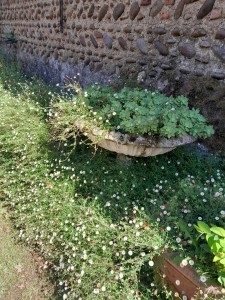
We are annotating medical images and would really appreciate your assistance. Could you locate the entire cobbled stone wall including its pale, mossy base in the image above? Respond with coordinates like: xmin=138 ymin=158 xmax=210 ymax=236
xmin=0 ymin=0 xmax=225 ymax=150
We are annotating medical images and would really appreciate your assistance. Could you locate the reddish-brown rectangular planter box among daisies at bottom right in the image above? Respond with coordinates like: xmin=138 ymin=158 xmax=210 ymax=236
xmin=156 ymin=254 xmax=225 ymax=300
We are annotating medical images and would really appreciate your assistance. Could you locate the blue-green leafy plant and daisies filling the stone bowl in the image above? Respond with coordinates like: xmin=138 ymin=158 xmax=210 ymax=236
xmin=49 ymin=85 xmax=214 ymax=142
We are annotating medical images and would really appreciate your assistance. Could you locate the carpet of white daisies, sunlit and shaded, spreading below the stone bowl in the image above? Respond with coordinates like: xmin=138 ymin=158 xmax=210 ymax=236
xmin=0 ymin=57 xmax=225 ymax=299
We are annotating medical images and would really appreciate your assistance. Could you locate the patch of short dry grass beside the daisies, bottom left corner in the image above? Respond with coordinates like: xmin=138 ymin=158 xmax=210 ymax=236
xmin=0 ymin=203 xmax=55 ymax=300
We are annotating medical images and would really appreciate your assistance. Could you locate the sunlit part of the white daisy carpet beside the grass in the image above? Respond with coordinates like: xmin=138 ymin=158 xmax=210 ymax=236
xmin=0 ymin=61 xmax=169 ymax=299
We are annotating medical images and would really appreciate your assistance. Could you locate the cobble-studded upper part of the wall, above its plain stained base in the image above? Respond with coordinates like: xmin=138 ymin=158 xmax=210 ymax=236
xmin=0 ymin=0 xmax=225 ymax=79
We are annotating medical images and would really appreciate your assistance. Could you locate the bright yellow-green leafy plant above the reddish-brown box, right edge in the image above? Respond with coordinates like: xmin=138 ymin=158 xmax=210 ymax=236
xmin=195 ymin=221 xmax=225 ymax=287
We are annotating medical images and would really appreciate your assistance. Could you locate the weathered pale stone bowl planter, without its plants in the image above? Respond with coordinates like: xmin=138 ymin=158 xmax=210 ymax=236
xmin=75 ymin=123 xmax=196 ymax=157
